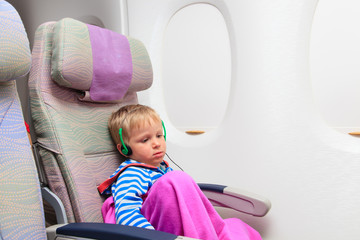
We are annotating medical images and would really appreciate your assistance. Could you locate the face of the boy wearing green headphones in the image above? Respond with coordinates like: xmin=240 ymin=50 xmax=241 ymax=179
xmin=129 ymin=122 xmax=166 ymax=167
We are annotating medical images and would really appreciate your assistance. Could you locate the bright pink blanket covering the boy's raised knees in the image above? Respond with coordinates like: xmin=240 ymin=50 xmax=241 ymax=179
xmin=102 ymin=171 xmax=261 ymax=240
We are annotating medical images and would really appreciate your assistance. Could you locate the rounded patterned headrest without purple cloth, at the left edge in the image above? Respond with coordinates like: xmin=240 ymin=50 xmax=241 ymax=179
xmin=0 ymin=1 xmax=31 ymax=82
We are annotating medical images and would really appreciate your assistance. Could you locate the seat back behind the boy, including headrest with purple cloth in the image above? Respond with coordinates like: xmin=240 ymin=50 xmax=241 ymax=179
xmin=29 ymin=18 xmax=152 ymax=222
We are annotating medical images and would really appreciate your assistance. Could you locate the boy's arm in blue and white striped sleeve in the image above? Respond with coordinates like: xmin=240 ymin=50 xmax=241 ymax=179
xmin=113 ymin=167 xmax=154 ymax=229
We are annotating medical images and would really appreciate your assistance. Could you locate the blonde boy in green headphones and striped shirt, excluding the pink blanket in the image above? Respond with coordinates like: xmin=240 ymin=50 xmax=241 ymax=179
xmin=100 ymin=105 xmax=172 ymax=229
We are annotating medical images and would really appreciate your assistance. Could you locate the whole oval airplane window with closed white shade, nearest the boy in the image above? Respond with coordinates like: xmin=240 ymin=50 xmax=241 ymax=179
xmin=162 ymin=4 xmax=231 ymax=133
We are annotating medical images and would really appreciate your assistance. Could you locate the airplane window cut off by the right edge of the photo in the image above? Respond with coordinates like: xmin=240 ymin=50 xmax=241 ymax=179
xmin=310 ymin=0 xmax=360 ymax=133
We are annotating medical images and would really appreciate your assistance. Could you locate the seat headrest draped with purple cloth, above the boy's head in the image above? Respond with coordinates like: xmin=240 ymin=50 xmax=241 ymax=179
xmin=51 ymin=18 xmax=153 ymax=102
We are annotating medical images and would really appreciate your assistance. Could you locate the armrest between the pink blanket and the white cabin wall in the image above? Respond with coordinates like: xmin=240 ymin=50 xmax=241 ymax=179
xmin=198 ymin=183 xmax=271 ymax=217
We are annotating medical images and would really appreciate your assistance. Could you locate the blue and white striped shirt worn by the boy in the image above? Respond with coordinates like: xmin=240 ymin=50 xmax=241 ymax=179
xmin=111 ymin=159 xmax=173 ymax=229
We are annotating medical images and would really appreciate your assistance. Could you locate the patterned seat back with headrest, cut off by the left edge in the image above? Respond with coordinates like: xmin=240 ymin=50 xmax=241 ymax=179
xmin=0 ymin=1 xmax=46 ymax=239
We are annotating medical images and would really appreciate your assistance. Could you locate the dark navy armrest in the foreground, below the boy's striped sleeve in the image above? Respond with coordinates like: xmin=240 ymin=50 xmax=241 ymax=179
xmin=56 ymin=223 xmax=198 ymax=240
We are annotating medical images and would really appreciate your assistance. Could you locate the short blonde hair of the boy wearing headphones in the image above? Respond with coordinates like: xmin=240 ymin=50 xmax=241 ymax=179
xmin=108 ymin=104 xmax=161 ymax=145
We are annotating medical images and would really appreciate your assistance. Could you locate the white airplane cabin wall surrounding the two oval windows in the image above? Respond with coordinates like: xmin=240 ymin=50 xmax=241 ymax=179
xmin=128 ymin=0 xmax=360 ymax=240
